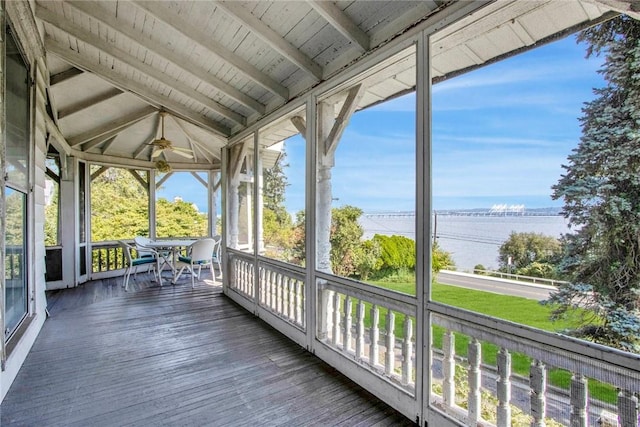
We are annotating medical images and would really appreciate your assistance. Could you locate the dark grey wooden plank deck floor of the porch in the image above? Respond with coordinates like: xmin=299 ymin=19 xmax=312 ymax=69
xmin=0 ymin=275 xmax=413 ymax=426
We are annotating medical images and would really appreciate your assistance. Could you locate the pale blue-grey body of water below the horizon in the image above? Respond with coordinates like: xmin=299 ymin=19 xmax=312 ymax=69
xmin=360 ymin=213 xmax=571 ymax=271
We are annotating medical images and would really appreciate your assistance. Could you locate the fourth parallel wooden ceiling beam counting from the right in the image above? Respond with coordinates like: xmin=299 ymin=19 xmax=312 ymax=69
xmin=67 ymin=0 xmax=265 ymax=115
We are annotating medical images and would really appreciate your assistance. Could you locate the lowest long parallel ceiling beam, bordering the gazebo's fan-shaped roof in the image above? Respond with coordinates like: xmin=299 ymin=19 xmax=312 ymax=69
xmin=45 ymin=38 xmax=231 ymax=138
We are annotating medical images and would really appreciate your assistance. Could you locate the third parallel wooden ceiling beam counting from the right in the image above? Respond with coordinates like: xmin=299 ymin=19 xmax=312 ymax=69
xmin=133 ymin=2 xmax=289 ymax=101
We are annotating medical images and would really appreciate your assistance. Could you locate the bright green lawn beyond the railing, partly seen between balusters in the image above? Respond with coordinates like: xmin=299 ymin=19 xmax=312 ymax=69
xmin=372 ymin=282 xmax=617 ymax=403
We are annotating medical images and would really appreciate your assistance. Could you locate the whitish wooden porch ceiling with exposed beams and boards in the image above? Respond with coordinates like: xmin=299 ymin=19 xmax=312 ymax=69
xmin=26 ymin=0 xmax=637 ymax=168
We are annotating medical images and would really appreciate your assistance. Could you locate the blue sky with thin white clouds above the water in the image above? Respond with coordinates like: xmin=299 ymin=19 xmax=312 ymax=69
xmin=159 ymin=36 xmax=604 ymax=216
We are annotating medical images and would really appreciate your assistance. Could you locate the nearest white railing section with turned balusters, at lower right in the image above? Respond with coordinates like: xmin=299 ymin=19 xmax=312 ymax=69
xmin=430 ymin=303 xmax=640 ymax=427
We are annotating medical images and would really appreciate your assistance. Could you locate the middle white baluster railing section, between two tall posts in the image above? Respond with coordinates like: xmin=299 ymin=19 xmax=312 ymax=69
xmin=318 ymin=277 xmax=416 ymax=396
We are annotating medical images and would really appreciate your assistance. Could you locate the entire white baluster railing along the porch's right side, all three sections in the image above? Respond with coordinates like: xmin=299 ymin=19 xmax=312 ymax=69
xmin=228 ymin=250 xmax=640 ymax=427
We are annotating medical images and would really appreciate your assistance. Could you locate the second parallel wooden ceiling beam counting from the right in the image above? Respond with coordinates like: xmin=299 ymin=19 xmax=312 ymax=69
xmin=216 ymin=1 xmax=322 ymax=81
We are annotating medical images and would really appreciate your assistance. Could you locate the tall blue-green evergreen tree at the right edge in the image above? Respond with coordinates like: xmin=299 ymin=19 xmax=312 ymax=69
xmin=548 ymin=16 xmax=640 ymax=351
